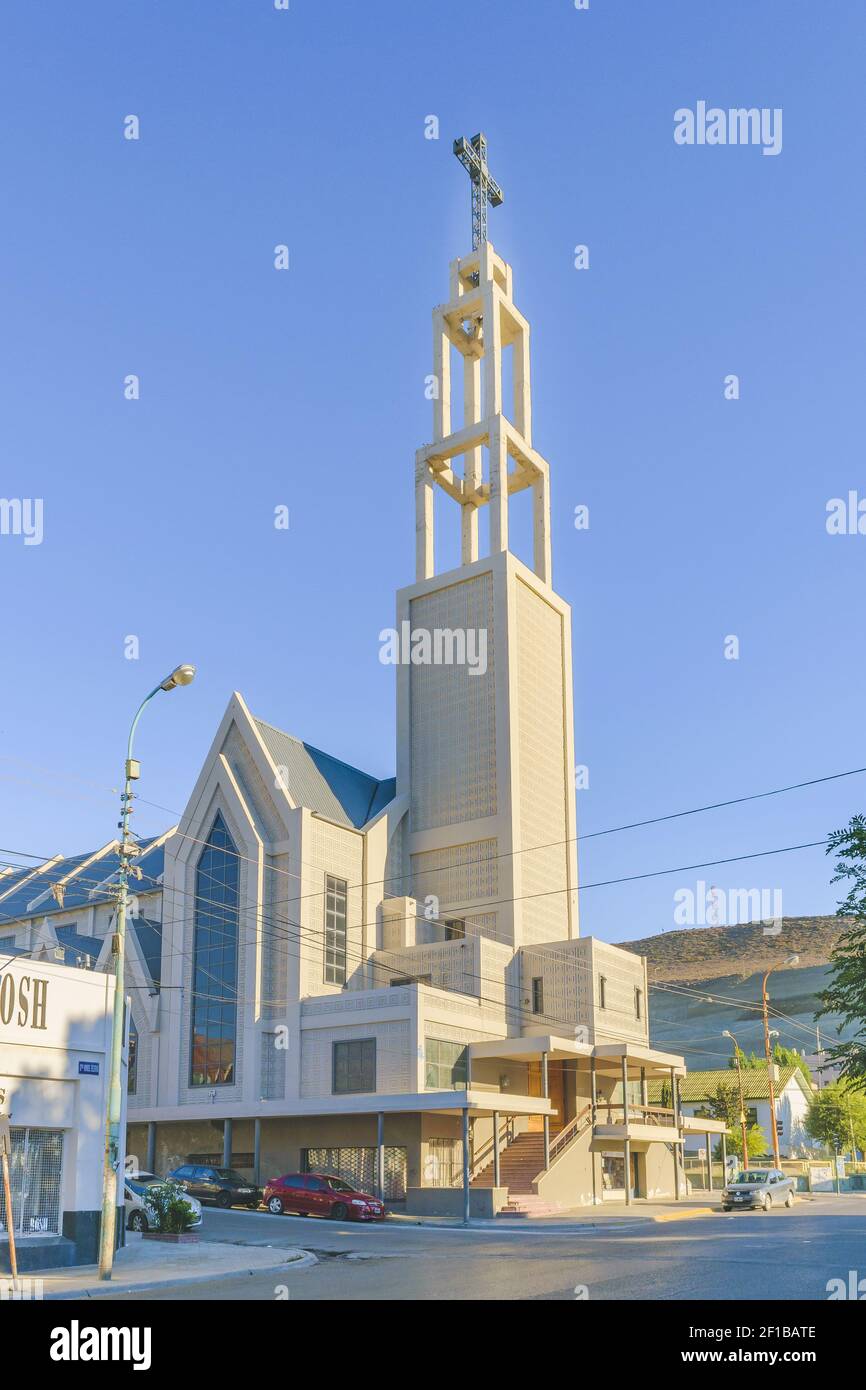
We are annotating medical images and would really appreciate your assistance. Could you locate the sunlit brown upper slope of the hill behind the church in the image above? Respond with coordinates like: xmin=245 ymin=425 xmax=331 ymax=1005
xmin=619 ymin=917 xmax=851 ymax=981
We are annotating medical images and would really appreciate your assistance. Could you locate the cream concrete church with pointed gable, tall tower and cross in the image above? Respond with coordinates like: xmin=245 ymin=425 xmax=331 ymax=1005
xmin=0 ymin=136 xmax=717 ymax=1216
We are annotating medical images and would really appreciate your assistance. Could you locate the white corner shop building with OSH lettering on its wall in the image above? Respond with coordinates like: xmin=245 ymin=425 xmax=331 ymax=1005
xmin=0 ymin=947 xmax=124 ymax=1270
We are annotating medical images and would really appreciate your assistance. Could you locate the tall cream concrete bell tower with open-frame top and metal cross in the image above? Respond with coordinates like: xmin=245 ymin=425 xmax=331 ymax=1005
xmin=392 ymin=135 xmax=578 ymax=947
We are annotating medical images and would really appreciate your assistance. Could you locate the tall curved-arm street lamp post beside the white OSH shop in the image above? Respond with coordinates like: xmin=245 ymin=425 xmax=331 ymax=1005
xmin=99 ymin=666 xmax=196 ymax=1279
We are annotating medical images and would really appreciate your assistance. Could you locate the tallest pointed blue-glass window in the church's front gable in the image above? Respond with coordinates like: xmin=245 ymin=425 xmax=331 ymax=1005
xmin=189 ymin=812 xmax=239 ymax=1086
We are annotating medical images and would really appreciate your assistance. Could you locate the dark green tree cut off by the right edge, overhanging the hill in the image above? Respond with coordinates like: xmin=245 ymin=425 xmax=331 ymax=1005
xmin=817 ymin=816 xmax=866 ymax=1094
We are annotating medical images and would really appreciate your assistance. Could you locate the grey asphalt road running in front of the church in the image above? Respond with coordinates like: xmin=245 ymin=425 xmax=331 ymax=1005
xmin=89 ymin=1197 xmax=866 ymax=1301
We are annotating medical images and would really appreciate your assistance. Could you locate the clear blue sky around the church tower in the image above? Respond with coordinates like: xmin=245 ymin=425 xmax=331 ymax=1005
xmin=0 ymin=0 xmax=866 ymax=941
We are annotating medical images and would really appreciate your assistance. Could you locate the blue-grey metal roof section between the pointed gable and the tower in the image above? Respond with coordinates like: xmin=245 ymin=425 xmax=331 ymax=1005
xmin=256 ymin=719 xmax=396 ymax=830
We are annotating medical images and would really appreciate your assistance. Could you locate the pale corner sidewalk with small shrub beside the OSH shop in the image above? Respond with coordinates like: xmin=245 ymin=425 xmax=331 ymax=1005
xmin=22 ymin=1232 xmax=316 ymax=1298
